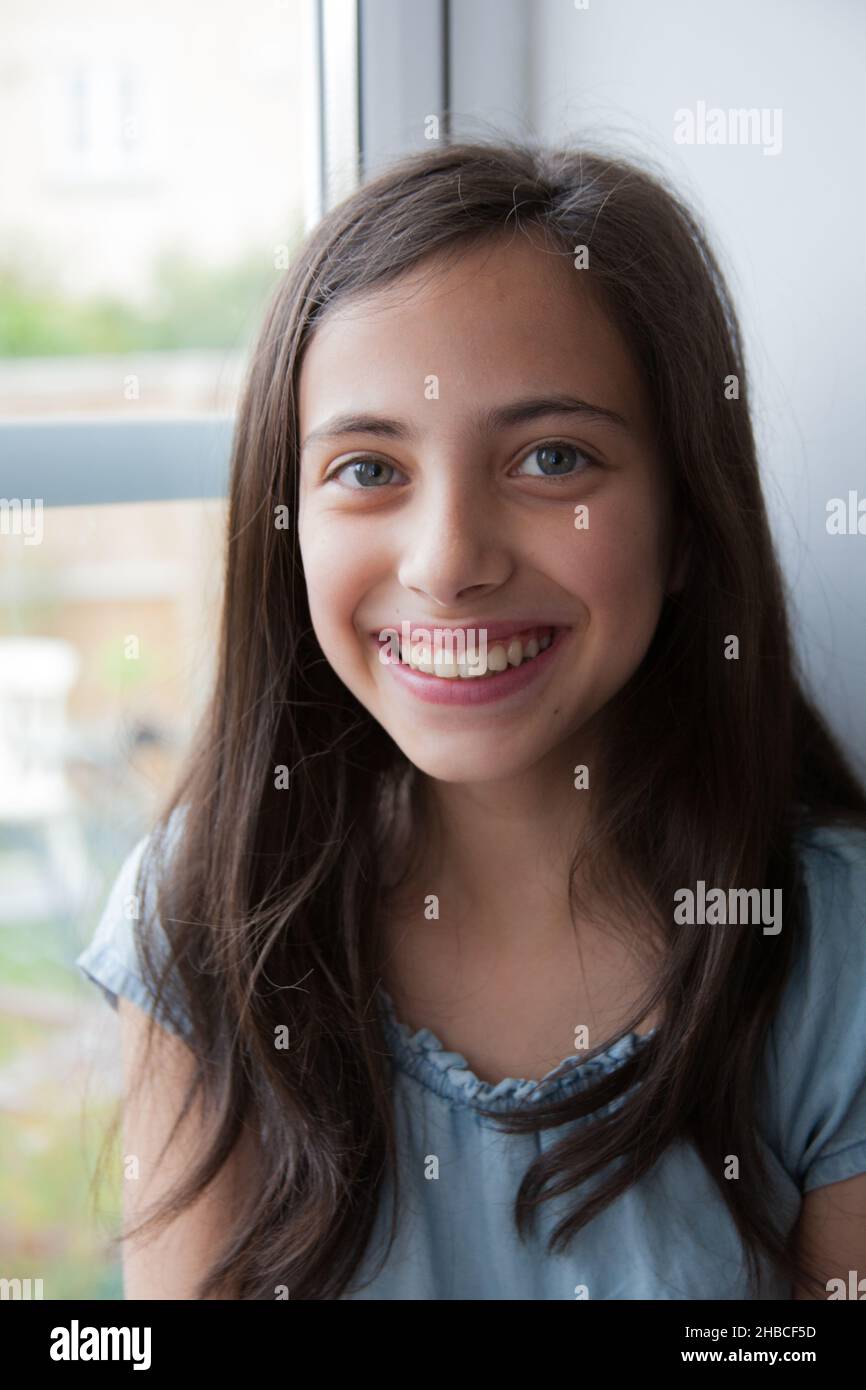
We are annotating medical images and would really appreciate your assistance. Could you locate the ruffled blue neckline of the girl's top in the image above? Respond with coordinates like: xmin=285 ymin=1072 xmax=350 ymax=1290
xmin=378 ymin=986 xmax=659 ymax=1111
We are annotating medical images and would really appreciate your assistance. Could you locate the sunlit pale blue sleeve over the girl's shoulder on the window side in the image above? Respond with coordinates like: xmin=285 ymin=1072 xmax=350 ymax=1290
xmin=75 ymin=808 xmax=189 ymax=1037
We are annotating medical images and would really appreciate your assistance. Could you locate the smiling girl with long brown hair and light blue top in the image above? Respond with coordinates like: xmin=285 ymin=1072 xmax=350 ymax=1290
xmin=79 ymin=142 xmax=866 ymax=1300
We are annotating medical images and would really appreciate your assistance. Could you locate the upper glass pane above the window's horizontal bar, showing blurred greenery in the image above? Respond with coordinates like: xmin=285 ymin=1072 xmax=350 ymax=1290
xmin=0 ymin=0 xmax=316 ymax=417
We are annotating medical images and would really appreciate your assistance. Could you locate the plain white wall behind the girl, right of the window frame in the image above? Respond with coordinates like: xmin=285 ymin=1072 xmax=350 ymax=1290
xmin=525 ymin=0 xmax=866 ymax=765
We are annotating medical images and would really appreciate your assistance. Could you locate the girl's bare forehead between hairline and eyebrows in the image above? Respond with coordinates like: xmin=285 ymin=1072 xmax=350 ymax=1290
xmin=299 ymin=234 xmax=651 ymax=432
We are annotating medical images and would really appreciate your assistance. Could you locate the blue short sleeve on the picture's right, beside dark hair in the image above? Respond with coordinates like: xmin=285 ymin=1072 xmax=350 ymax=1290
xmin=767 ymin=826 xmax=866 ymax=1193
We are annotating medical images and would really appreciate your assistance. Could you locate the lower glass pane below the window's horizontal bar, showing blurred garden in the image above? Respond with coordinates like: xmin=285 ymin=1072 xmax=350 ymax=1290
xmin=0 ymin=500 xmax=227 ymax=1298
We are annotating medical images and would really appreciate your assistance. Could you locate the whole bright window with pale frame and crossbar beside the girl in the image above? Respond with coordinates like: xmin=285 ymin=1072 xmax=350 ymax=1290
xmin=0 ymin=0 xmax=523 ymax=1298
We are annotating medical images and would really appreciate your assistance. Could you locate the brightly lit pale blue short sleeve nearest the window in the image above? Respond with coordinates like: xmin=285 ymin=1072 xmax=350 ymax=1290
xmin=75 ymin=823 xmax=192 ymax=1038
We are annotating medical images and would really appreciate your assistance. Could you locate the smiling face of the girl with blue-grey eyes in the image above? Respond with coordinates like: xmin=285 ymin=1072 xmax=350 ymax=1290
xmin=299 ymin=236 xmax=680 ymax=783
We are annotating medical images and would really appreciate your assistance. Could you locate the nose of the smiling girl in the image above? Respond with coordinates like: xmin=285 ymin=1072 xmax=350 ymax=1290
xmin=398 ymin=459 xmax=514 ymax=607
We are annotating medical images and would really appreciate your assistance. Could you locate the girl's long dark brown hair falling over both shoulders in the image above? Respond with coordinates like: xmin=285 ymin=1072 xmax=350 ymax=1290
xmin=108 ymin=139 xmax=866 ymax=1298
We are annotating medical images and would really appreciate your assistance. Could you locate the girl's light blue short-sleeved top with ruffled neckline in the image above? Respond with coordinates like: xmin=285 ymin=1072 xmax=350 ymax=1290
xmin=78 ymin=827 xmax=866 ymax=1300
